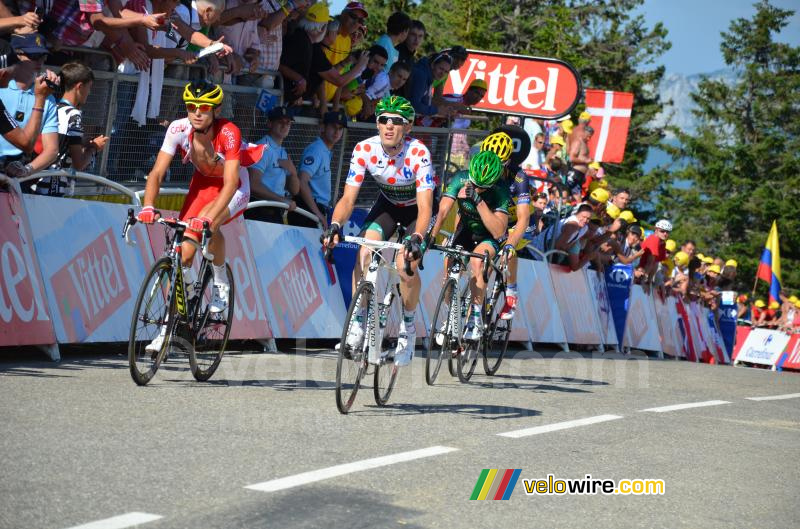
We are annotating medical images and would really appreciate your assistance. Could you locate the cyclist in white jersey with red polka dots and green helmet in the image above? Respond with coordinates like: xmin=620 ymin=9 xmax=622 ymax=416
xmin=323 ymin=96 xmax=436 ymax=366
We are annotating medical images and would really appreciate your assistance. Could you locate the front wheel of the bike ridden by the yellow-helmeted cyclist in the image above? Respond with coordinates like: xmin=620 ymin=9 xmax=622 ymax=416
xmin=128 ymin=257 xmax=176 ymax=386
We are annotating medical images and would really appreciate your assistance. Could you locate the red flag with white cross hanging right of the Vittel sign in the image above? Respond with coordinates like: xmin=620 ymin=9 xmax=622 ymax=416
xmin=586 ymin=90 xmax=633 ymax=163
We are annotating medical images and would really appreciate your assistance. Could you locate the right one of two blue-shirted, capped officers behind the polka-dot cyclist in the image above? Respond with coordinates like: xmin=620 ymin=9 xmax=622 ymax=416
xmin=290 ymin=111 xmax=347 ymax=229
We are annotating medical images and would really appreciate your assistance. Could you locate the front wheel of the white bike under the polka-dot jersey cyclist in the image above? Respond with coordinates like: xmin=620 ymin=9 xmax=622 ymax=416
xmin=336 ymin=281 xmax=377 ymax=414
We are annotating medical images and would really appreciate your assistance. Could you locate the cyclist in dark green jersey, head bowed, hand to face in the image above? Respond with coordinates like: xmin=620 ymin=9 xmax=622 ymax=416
xmin=432 ymin=151 xmax=511 ymax=340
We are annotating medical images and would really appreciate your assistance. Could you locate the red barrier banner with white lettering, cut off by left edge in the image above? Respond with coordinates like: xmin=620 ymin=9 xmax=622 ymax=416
xmin=0 ymin=193 xmax=56 ymax=346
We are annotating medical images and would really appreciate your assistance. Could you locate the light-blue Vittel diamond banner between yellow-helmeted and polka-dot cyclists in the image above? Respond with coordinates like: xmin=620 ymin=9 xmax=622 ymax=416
xmin=245 ymin=221 xmax=349 ymax=338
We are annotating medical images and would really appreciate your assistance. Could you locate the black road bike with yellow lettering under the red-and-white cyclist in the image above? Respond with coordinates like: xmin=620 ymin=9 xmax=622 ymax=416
xmin=122 ymin=209 xmax=235 ymax=386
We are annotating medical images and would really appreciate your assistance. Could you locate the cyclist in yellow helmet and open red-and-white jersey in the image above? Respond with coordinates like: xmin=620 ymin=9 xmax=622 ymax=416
xmin=137 ymin=81 xmax=265 ymax=350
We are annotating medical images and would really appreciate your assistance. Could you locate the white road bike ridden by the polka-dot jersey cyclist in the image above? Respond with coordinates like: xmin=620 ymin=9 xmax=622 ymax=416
xmin=325 ymin=224 xmax=414 ymax=414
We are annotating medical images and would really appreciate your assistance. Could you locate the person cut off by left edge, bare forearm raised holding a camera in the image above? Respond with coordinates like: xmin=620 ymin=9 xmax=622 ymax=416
xmin=0 ymin=41 xmax=58 ymax=172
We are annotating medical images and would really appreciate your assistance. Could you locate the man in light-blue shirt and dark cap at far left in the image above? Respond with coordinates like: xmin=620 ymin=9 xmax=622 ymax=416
xmin=0 ymin=33 xmax=58 ymax=190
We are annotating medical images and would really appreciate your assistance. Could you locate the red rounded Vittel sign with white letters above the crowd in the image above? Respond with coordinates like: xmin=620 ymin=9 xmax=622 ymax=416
xmin=444 ymin=50 xmax=581 ymax=119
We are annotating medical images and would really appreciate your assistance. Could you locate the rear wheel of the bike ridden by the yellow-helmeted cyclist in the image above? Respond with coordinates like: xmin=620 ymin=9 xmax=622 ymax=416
xmin=188 ymin=263 xmax=236 ymax=382
